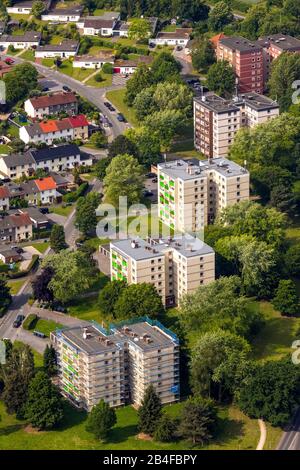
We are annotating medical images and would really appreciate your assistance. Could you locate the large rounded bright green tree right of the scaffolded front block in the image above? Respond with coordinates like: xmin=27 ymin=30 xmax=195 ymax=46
xmin=191 ymin=330 xmax=250 ymax=401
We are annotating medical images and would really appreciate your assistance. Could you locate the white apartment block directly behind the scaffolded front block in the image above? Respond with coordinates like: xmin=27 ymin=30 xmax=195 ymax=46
xmin=110 ymin=236 xmax=215 ymax=306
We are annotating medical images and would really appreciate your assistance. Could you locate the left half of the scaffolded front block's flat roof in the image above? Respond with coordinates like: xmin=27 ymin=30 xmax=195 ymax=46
xmin=57 ymin=324 xmax=119 ymax=355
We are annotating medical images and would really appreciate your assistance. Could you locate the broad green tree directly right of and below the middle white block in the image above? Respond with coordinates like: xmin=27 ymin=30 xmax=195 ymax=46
xmin=180 ymin=276 xmax=261 ymax=337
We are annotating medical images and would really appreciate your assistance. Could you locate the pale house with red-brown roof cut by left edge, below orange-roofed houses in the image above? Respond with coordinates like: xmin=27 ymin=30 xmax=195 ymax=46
xmin=0 ymin=212 xmax=32 ymax=243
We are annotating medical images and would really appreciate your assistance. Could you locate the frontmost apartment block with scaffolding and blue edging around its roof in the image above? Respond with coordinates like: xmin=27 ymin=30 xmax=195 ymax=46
xmin=51 ymin=318 xmax=180 ymax=411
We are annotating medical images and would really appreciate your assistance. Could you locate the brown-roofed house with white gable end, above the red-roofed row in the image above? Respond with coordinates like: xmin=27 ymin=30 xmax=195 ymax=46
xmin=24 ymin=92 xmax=78 ymax=119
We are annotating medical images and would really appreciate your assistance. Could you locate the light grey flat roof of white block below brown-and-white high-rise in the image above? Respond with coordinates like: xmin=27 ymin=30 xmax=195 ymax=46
xmin=157 ymin=157 xmax=248 ymax=181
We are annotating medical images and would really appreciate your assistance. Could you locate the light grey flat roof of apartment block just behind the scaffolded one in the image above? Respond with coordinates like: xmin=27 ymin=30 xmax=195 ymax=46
xmin=110 ymin=235 xmax=214 ymax=261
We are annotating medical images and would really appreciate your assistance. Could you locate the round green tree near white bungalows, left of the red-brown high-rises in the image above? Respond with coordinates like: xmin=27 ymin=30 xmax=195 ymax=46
xmin=151 ymin=52 xmax=182 ymax=83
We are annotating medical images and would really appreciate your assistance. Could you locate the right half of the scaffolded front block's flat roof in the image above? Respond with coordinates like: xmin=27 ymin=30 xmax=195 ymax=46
xmin=113 ymin=321 xmax=175 ymax=351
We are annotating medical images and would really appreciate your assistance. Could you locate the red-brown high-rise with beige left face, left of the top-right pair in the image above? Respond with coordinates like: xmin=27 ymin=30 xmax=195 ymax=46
xmin=217 ymin=36 xmax=265 ymax=94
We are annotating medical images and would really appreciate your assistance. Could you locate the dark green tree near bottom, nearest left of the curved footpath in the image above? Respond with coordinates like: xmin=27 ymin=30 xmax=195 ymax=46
xmin=179 ymin=398 xmax=216 ymax=445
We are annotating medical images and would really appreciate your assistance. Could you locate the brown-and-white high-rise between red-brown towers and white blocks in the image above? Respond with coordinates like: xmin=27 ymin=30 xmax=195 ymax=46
xmin=194 ymin=93 xmax=279 ymax=158
